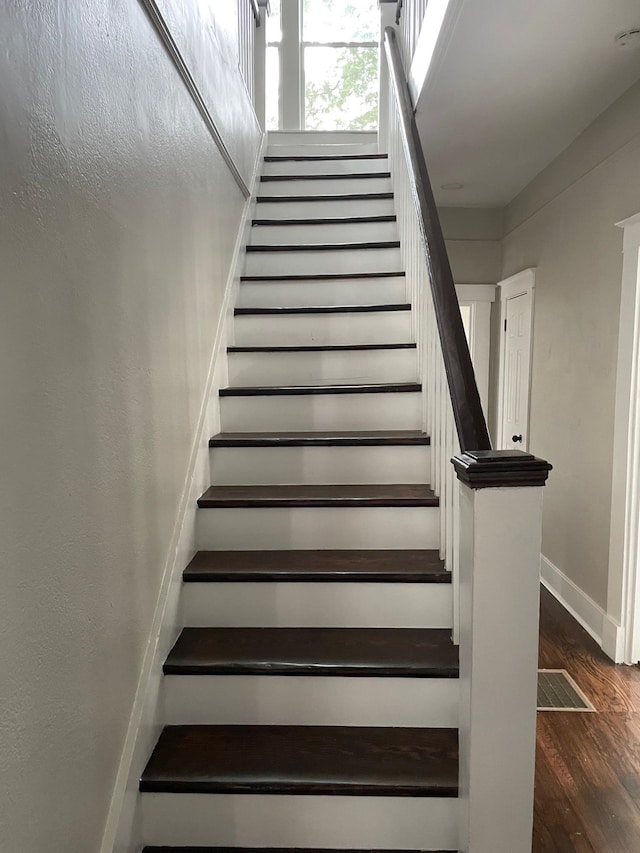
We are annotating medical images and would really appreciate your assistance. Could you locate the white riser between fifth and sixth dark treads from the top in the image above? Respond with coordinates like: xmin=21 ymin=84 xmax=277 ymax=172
xmin=244 ymin=249 xmax=402 ymax=276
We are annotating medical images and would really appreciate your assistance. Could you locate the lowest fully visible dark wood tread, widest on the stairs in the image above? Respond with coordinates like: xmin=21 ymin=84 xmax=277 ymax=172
xmin=140 ymin=726 xmax=458 ymax=797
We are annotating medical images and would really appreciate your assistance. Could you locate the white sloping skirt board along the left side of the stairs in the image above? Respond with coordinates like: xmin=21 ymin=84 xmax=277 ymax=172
xmin=100 ymin=134 xmax=266 ymax=853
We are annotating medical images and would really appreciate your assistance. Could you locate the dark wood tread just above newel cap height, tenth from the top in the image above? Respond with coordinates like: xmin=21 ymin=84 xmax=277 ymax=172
xmin=209 ymin=430 xmax=431 ymax=447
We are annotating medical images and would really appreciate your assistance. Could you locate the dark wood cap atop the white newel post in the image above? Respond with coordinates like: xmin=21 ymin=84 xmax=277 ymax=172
xmin=451 ymin=450 xmax=553 ymax=489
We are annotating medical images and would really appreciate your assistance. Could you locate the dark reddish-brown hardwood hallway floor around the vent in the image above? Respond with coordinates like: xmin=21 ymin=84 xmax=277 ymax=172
xmin=533 ymin=589 xmax=640 ymax=853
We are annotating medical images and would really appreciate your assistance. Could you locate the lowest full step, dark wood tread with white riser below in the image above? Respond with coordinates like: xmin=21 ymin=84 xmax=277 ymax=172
xmin=140 ymin=726 xmax=460 ymax=850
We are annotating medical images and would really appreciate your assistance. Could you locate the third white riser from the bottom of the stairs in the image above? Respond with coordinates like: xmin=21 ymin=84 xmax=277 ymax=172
xmin=181 ymin=581 xmax=453 ymax=628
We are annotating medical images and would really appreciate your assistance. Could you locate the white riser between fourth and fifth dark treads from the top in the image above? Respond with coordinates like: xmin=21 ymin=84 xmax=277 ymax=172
xmin=249 ymin=222 xmax=398 ymax=246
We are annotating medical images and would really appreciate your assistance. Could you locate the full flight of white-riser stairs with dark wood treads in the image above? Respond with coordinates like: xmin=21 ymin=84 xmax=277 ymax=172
xmin=140 ymin=133 xmax=459 ymax=853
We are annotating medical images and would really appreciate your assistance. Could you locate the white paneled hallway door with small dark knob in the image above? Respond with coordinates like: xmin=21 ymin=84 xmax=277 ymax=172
xmin=500 ymin=293 xmax=531 ymax=450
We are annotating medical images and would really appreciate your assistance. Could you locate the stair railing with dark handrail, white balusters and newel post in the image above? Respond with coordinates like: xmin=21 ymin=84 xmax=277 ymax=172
xmin=380 ymin=20 xmax=551 ymax=853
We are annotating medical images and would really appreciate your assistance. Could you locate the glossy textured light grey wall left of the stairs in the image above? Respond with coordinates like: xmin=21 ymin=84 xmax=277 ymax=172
xmin=0 ymin=0 xmax=258 ymax=853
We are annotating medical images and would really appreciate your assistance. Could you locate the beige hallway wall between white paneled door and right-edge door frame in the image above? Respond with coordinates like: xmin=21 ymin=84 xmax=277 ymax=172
xmin=503 ymin=78 xmax=640 ymax=609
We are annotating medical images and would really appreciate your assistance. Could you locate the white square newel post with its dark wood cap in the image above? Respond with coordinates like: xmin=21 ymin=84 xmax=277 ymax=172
xmin=452 ymin=450 xmax=551 ymax=853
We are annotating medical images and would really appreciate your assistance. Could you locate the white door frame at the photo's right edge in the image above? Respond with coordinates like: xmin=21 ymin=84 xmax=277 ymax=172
xmin=602 ymin=213 xmax=640 ymax=664
